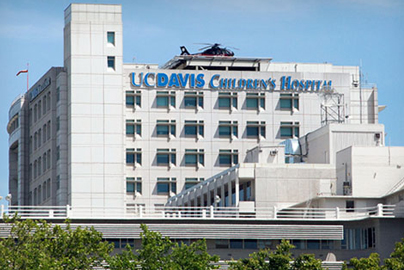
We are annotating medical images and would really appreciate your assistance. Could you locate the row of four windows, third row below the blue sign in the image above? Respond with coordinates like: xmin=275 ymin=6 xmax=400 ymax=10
xmin=126 ymin=148 xmax=239 ymax=167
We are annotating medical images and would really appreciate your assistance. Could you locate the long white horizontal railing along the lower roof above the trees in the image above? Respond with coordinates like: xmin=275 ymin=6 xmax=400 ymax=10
xmin=0 ymin=204 xmax=395 ymax=220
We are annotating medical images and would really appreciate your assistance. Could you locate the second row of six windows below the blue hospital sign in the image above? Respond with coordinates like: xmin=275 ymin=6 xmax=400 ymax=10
xmin=126 ymin=119 xmax=300 ymax=139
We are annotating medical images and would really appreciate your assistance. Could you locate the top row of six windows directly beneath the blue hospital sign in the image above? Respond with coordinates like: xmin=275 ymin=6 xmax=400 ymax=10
xmin=126 ymin=91 xmax=299 ymax=110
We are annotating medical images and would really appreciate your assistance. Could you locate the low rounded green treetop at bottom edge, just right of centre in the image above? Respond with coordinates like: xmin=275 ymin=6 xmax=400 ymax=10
xmin=230 ymin=240 xmax=323 ymax=270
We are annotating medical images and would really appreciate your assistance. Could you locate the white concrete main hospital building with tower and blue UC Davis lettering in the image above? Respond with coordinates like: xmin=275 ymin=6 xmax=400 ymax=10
xmin=9 ymin=4 xmax=384 ymax=214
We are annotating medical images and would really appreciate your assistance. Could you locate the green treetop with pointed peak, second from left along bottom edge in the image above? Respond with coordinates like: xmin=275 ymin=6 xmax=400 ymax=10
xmin=108 ymin=225 xmax=219 ymax=270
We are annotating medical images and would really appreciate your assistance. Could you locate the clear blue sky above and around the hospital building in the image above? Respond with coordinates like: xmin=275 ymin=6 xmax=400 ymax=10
xmin=0 ymin=0 xmax=404 ymax=200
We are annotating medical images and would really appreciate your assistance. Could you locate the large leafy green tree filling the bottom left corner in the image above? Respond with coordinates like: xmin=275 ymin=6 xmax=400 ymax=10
xmin=0 ymin=217 xmax=112 ymax=270
